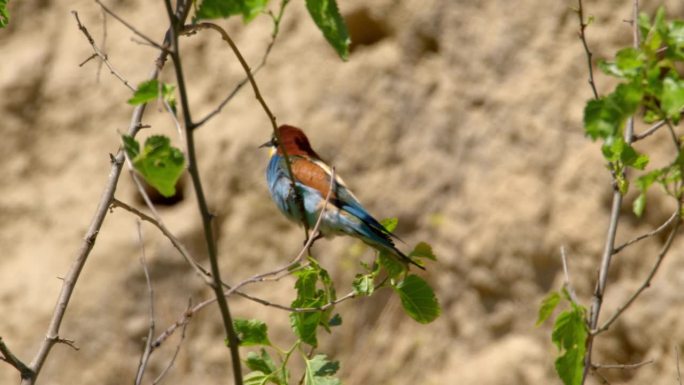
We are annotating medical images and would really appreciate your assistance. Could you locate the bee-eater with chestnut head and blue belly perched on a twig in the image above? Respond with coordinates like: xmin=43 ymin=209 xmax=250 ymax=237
xmin=259 ymin=124 xmax=425 ymax=270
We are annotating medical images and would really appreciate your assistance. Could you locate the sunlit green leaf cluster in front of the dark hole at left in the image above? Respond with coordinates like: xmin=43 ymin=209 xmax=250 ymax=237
xmin=122 ymin=135 xmax=185 ymax=197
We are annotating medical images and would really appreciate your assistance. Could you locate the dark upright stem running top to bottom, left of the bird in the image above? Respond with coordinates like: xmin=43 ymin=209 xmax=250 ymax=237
xmin=164 ymin=0 xmax=242 ymax=385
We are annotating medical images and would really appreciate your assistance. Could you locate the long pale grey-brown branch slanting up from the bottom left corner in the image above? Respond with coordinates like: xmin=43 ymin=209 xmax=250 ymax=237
xmin=21 ymin=3 xmax=188 ymax=385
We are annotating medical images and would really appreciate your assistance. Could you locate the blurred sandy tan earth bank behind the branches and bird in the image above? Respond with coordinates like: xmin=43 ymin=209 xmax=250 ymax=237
xmin=0 ymin=0 xmax=684 ymax=385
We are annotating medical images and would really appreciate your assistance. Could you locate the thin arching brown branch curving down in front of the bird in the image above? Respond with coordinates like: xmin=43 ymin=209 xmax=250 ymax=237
xmin=184 ymin=23 xmax=315 ymax=240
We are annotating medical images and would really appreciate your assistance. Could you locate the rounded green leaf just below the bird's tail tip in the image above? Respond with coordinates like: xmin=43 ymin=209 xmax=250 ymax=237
xmin=394 ymin=274 xmax=441 ymax=324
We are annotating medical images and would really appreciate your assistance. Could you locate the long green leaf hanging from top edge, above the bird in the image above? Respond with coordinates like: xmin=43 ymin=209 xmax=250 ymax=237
xmin=306 ymin=0 xmax=351 ymax=60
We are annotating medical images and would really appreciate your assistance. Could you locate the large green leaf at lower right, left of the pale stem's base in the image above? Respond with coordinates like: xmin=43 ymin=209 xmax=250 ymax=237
xmin=551 ymin=304 xmax=587 ymax=385
